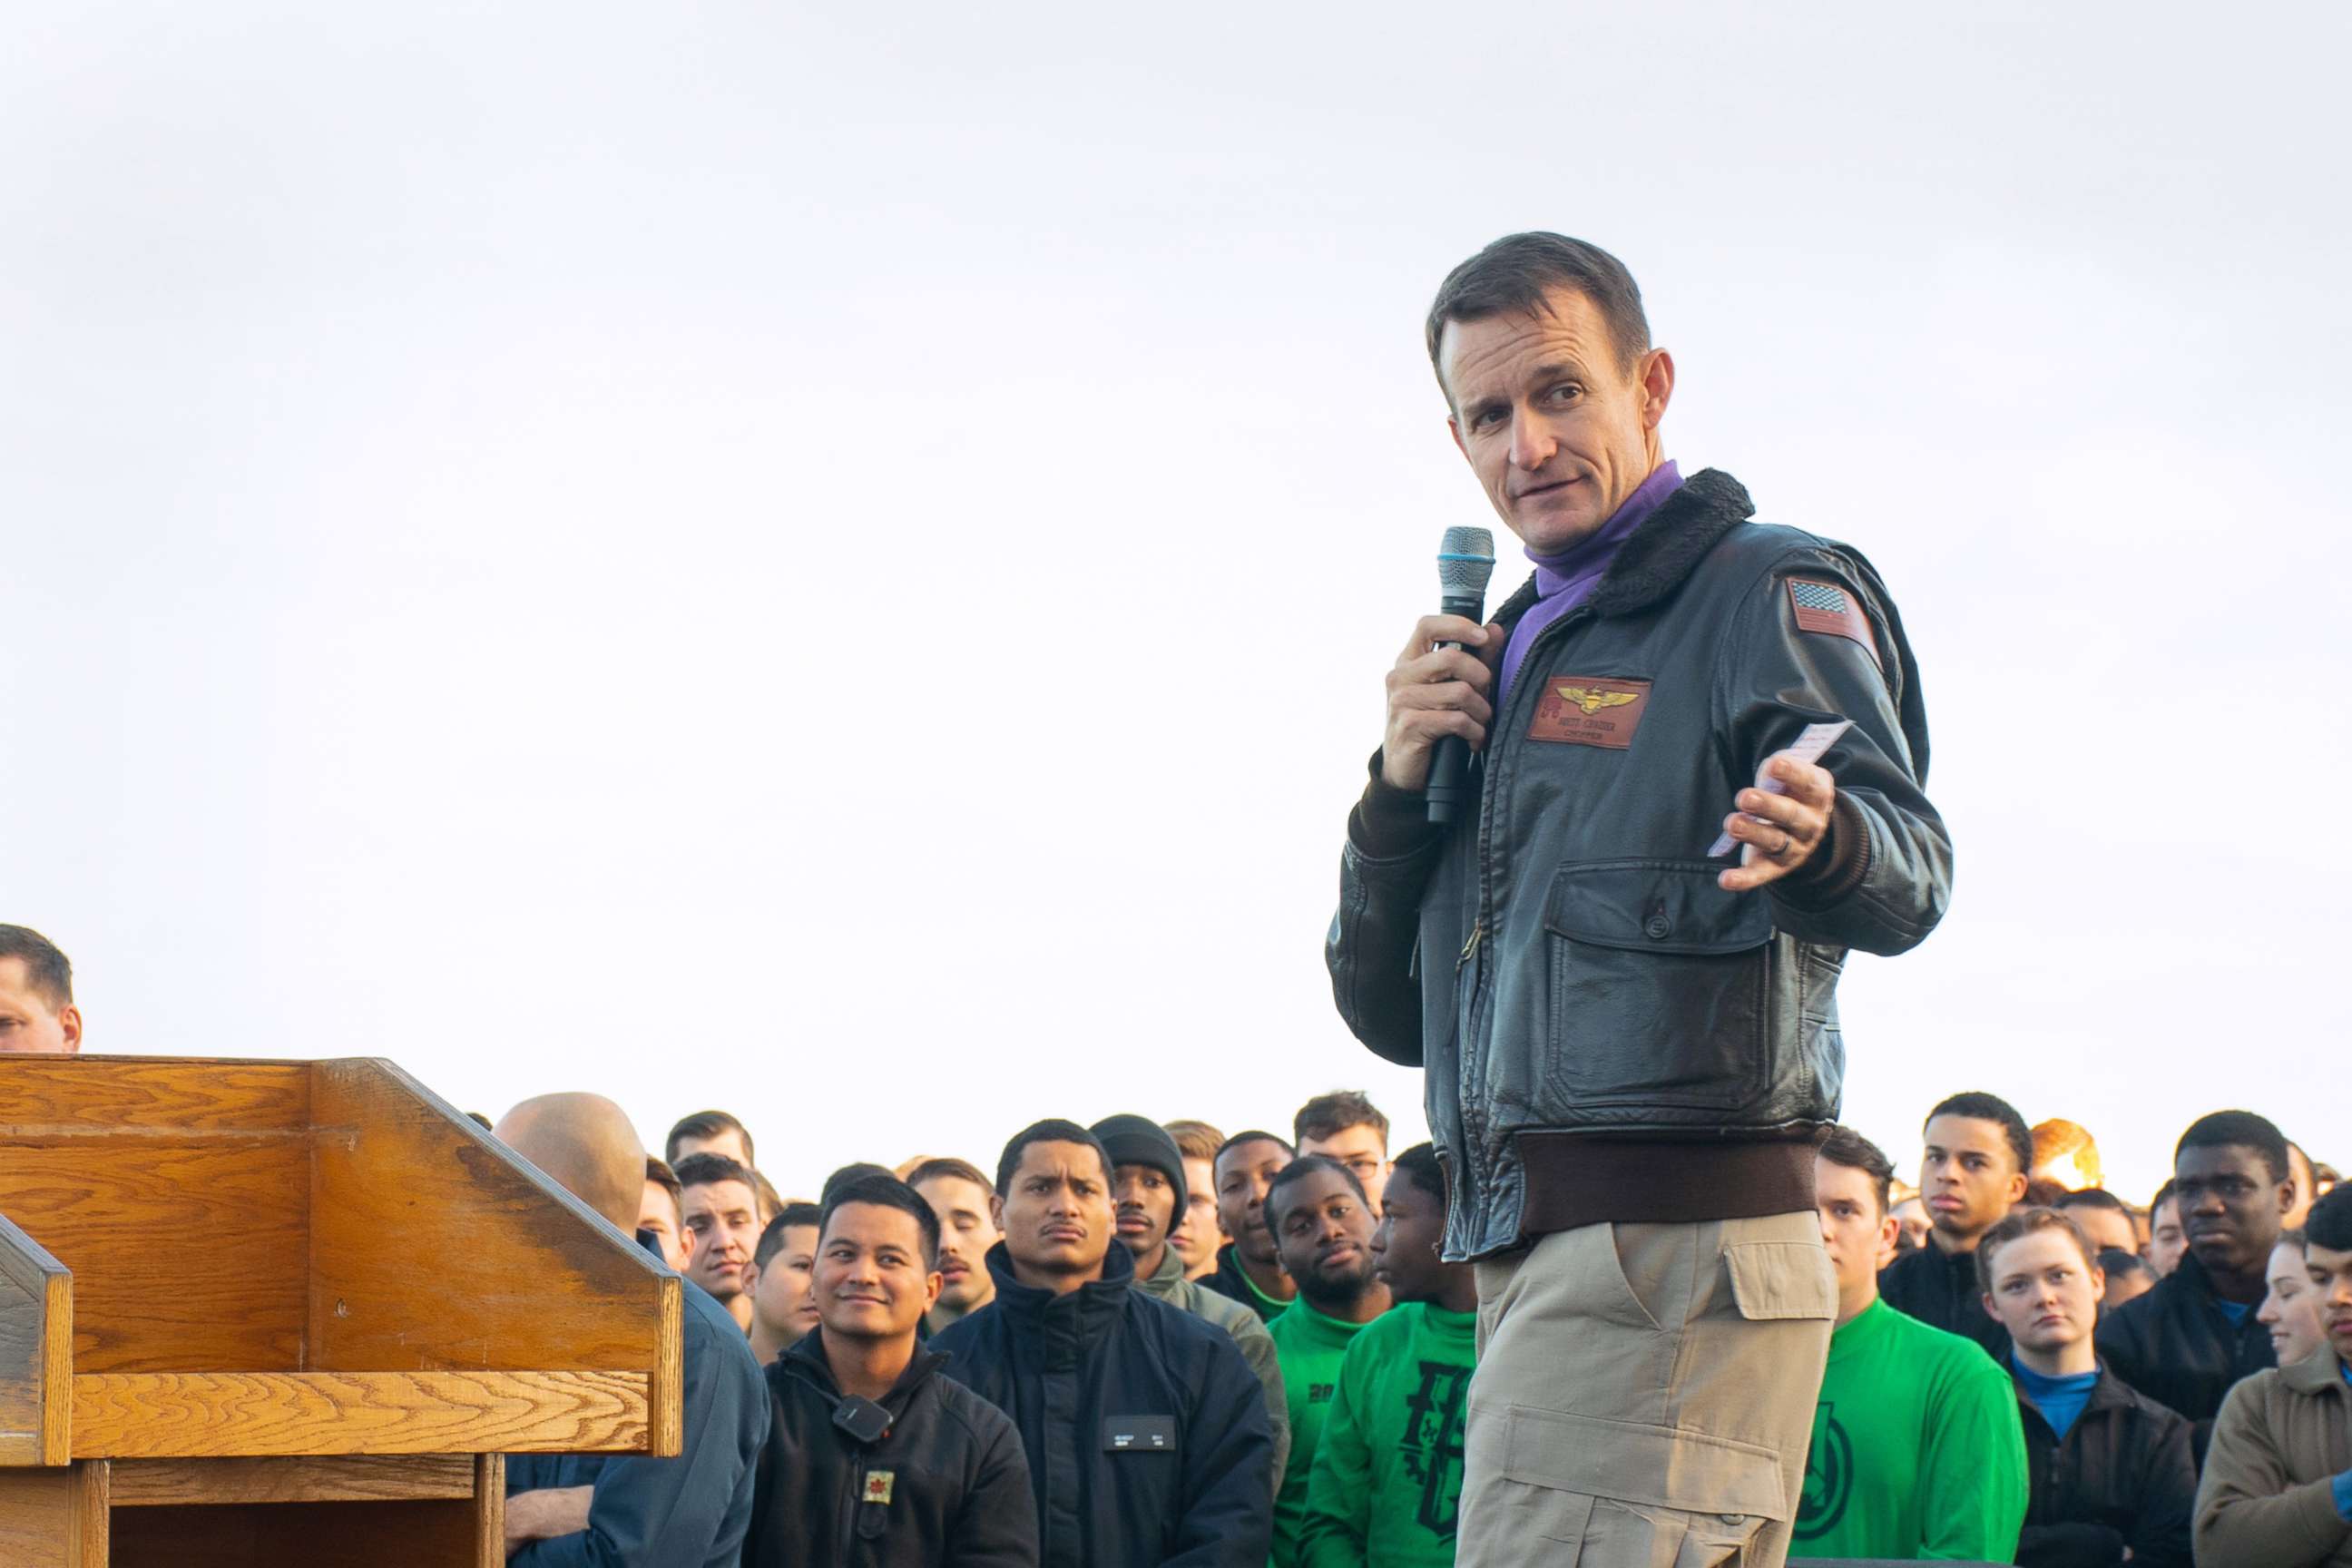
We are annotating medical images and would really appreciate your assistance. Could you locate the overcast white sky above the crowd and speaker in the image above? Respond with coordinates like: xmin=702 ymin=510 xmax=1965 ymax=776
xmin=0 ymin=3 xmax=2352 ymax=1199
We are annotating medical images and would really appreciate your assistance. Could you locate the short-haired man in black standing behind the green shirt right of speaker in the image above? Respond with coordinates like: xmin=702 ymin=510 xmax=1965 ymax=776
xmin=1879 ymin=1093 xmax=2034 ymax=1358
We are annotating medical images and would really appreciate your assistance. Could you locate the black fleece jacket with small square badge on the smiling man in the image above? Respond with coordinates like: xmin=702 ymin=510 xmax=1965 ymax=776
xmin=743 ymin=1328 xmax=1037 ymax=1568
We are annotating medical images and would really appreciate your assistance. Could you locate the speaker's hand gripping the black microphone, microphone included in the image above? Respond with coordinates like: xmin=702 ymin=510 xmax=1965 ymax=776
xmin=1381 ymin=529 xmax=1503 ymax=823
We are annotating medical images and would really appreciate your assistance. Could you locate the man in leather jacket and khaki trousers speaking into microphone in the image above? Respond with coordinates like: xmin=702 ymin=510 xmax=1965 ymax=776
xmin=1327 ymin=232 xmax=1952 ymax=1568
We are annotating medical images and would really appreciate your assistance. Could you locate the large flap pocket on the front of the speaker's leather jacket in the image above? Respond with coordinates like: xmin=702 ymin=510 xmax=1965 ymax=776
xmin=1545 ymin=860 xmax=1773 ymax=1122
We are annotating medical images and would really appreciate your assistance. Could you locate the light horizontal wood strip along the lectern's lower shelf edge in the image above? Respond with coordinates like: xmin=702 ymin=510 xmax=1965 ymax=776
xmin=73 ymin=1370 xmax=647 ymax=1460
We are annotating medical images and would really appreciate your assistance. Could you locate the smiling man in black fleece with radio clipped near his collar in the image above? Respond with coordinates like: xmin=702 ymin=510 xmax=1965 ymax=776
xmin=743 ymin=1175 xmax=1037 ymax=1568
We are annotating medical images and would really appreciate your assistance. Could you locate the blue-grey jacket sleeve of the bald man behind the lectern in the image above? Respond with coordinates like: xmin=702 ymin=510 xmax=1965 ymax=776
xmin=505 ymin=1305 xmax=769 ymax=1568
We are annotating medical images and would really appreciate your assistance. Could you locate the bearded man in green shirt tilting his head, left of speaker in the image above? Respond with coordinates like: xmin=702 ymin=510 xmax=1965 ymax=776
xmin=1265 ymin=1154 xmax=1390 ymax=1568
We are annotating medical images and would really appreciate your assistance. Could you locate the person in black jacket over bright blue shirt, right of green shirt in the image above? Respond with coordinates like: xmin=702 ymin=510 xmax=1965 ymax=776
xmin=1975 ymin=1209 xmax=2197 ymax=1568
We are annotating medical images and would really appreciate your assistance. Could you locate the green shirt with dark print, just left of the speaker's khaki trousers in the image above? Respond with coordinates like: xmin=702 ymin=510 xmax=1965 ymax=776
xmin=1298 ymin=1302 xmax=1477 ymax=1568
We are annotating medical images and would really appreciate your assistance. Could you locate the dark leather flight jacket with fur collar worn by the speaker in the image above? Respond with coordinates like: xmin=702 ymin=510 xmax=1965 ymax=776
xmin=1324 ymin=470 xmax=1952 ymax=1260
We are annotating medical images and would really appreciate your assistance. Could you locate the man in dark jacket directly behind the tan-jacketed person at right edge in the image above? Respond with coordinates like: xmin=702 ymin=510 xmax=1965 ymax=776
xmin=2098 ymin=1110 xmax=2296 ymax=1455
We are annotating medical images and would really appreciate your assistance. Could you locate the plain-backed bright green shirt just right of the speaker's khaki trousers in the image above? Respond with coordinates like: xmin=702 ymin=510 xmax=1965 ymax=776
xmin=1792 ymin=1302 xmax=2025 ymax=1563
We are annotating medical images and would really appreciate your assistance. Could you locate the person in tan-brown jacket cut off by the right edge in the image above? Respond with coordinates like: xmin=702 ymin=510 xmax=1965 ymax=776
xmin=2185 ymin=1187 xmax=2352 ymax=1568
